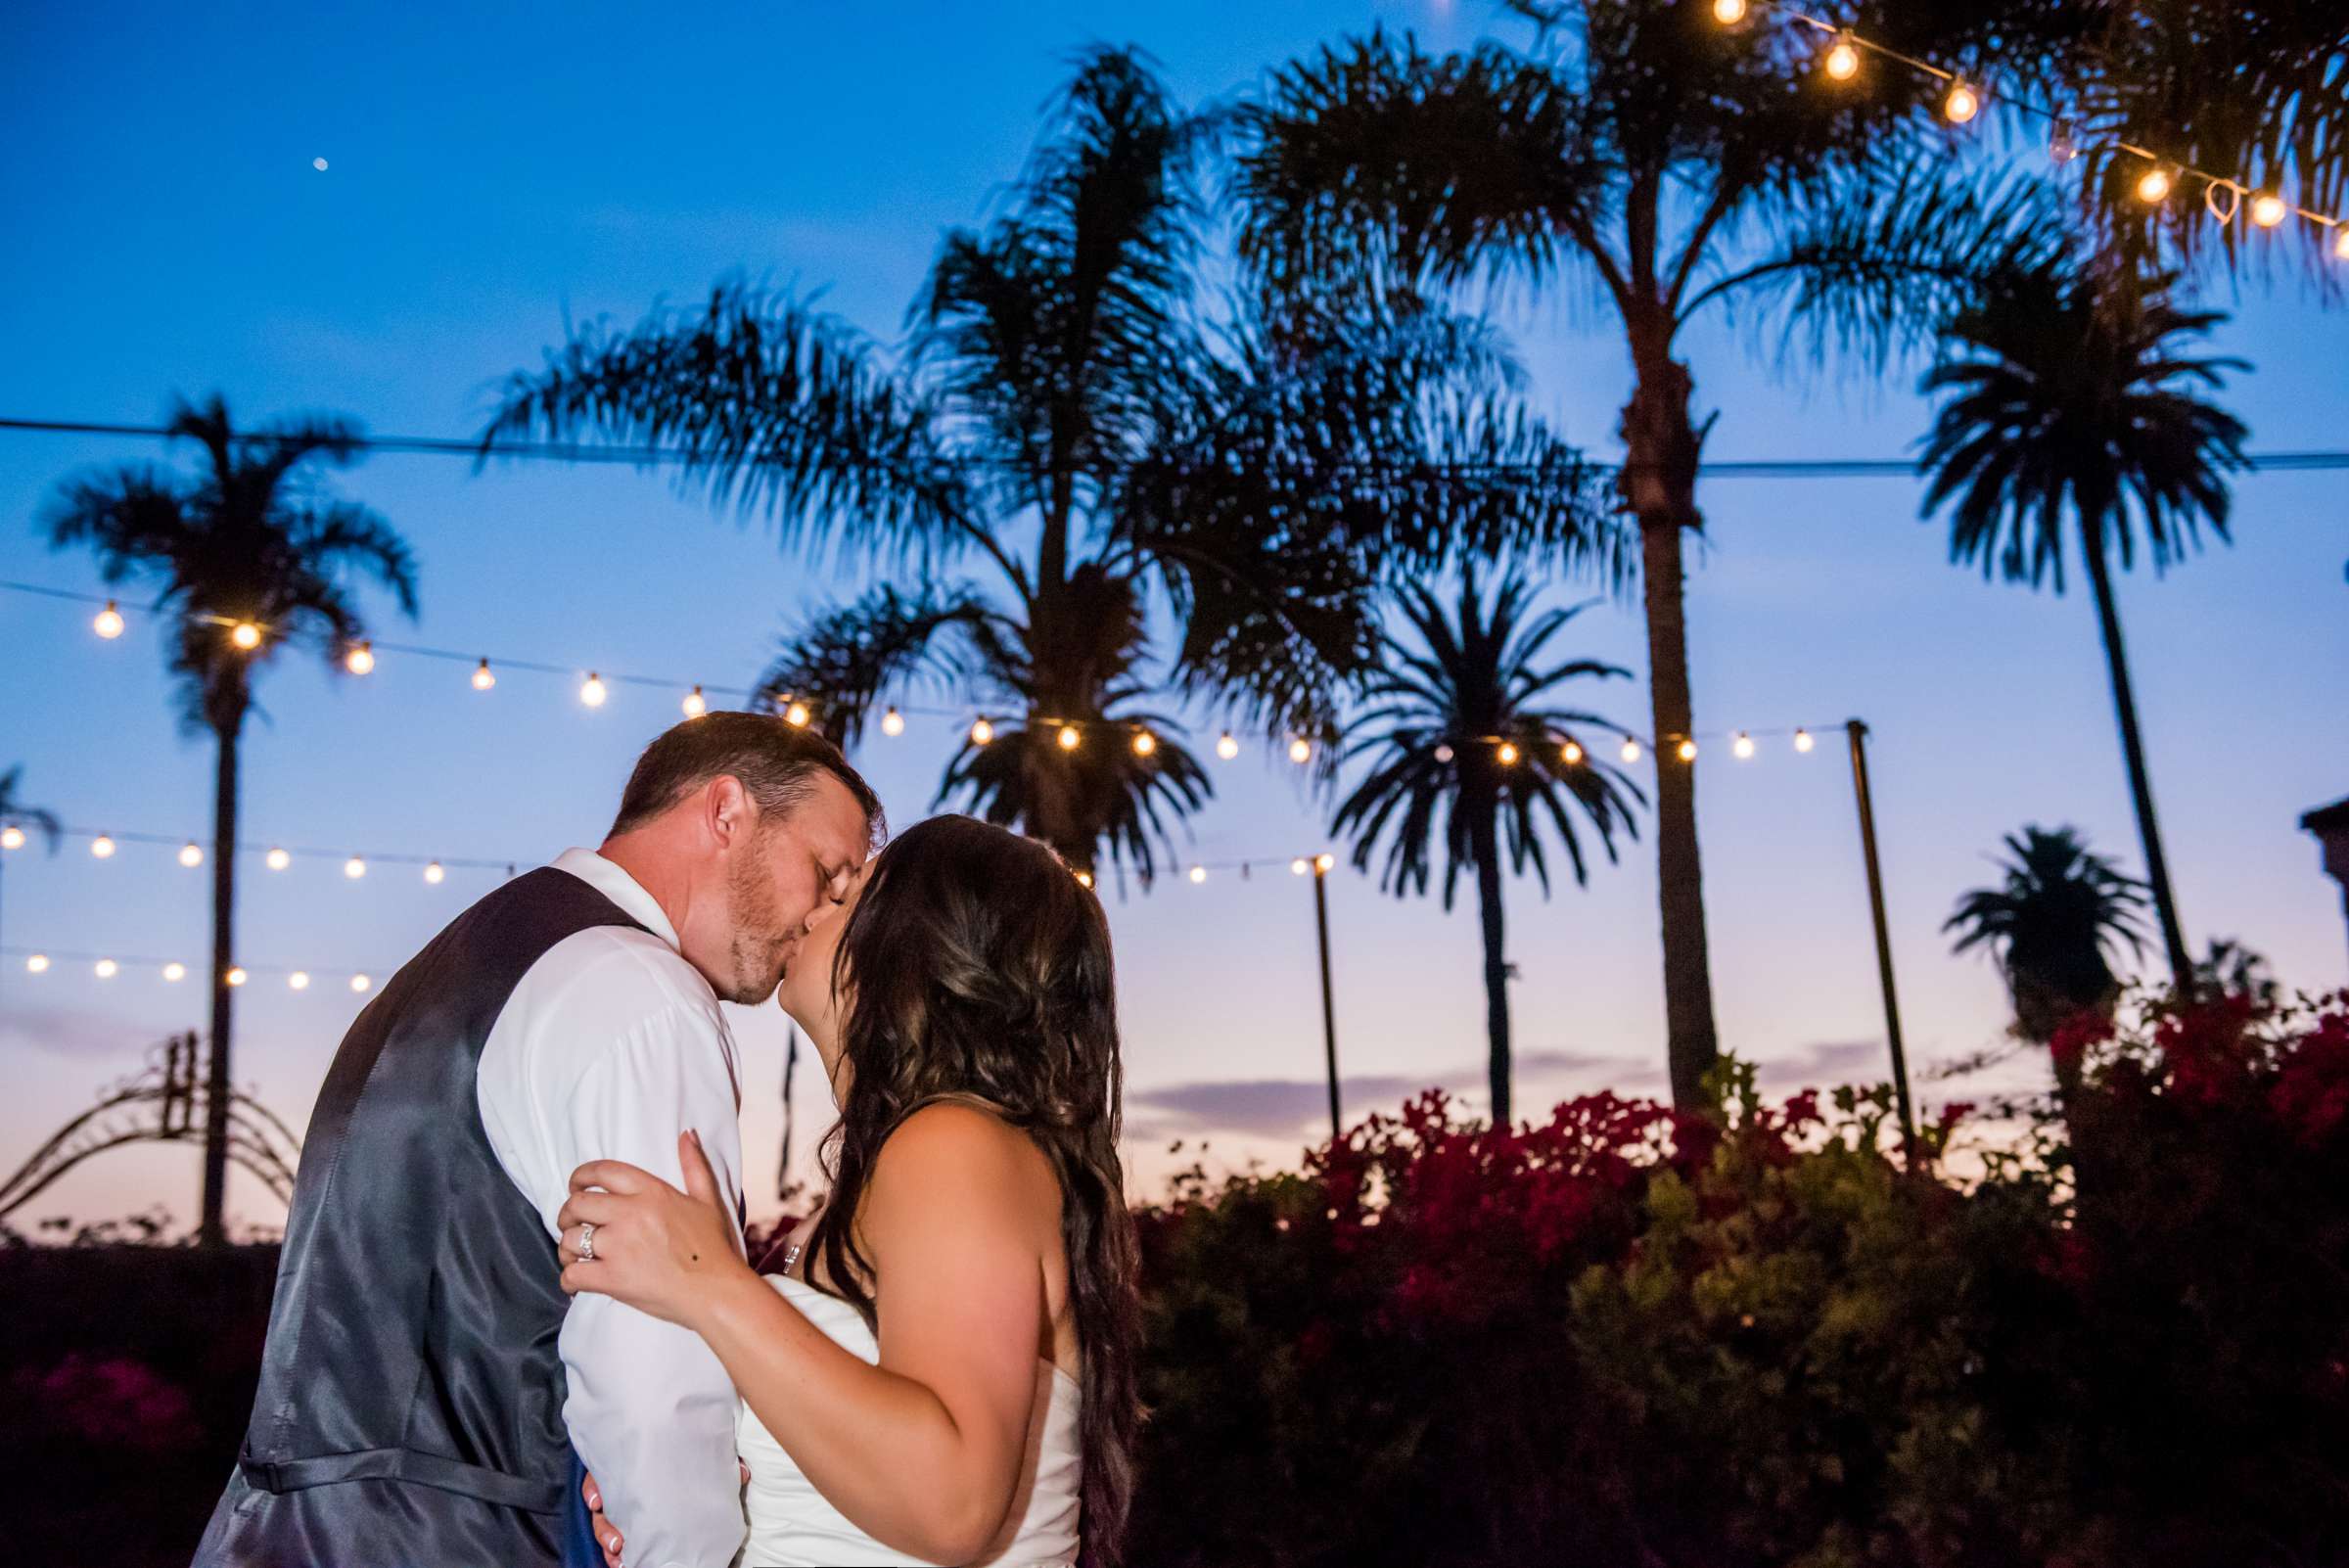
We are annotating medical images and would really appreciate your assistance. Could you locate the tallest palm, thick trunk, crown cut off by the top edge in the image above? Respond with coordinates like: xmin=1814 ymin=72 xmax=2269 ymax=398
xmin=1238 ymin=0 xmax=2074 ymax=1108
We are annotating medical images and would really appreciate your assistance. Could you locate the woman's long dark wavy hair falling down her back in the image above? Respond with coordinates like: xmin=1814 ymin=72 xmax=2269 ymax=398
xmin=810 ymin=817 xmax=1141 ymax=1563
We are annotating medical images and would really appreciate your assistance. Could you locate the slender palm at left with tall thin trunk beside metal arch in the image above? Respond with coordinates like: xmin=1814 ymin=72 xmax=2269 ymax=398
xmin=42 ymin=396 xmax=416 ymax=1242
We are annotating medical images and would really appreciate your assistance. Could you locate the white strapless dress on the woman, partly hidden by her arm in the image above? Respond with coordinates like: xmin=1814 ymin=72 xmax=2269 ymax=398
xmin=735 ymin=1274 xmax=1082 ymax=1568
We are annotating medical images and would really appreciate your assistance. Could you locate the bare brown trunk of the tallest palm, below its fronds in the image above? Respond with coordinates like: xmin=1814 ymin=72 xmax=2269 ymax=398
xmin=1621 ymin=345 xmax=1720 ymax=1110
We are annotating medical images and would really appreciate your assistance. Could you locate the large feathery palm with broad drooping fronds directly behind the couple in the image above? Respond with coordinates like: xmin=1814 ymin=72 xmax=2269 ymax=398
xmin=484 ymin=49 xmax=1604 ymax=878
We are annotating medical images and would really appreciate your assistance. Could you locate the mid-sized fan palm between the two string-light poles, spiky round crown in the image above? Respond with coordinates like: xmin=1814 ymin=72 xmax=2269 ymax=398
xmin=1329 ymin=571 xmax=1642 ymax=1130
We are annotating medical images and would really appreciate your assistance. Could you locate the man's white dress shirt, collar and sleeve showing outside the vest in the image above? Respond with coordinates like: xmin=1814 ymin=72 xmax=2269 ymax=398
xmin=475 ymin=850 xmax=745 ymax=1568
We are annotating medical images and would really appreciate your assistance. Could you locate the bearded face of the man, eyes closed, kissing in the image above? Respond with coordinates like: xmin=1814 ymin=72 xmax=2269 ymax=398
xmin=716 ymin=772 xmax=871 ymax=1007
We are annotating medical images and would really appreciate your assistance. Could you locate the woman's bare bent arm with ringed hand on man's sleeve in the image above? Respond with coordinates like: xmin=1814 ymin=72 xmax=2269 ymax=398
xmin=562 ymin=1106 xmax=1059 ymax=1563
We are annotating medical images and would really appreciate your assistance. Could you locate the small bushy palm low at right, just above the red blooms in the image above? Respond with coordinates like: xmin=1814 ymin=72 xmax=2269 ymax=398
xmin=1940 ymin=826 xmax=2144 ymax=1080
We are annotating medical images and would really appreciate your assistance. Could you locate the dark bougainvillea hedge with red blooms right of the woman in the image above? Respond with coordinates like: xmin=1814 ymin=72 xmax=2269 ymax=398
xmin=1132 ymin=997 xmax=2349 ymax=1568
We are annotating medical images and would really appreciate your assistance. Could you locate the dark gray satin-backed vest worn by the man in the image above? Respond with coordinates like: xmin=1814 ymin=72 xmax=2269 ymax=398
xmin=198 ymin=868 xmax=644 ymax=1568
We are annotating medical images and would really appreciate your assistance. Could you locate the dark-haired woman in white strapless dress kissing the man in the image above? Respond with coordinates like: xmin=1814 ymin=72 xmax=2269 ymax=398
xmin=562 ymin=817 xmax=1139 ymax=1568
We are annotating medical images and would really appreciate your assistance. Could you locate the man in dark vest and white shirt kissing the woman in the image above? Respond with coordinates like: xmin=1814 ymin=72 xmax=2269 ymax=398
xmin=195 ymin=714 xmax=881 ymax=1568
